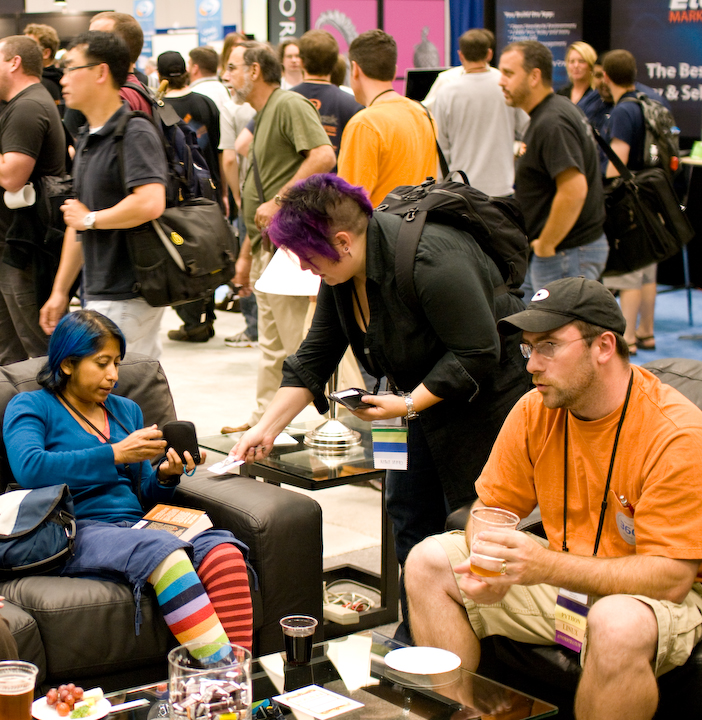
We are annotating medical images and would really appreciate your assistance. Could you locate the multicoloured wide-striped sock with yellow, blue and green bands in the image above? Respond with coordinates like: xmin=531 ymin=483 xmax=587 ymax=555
xmin=149 ymin=550 xmax=229 ymax=661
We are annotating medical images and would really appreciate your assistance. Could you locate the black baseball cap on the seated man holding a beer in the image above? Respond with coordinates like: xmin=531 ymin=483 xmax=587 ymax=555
xmin=497 ymin=277 xmax=626 ymax=335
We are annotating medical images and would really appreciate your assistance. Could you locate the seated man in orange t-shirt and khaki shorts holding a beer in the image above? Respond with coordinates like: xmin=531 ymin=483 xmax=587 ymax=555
xmin=405 ymin=278 xmax=702 ymax=720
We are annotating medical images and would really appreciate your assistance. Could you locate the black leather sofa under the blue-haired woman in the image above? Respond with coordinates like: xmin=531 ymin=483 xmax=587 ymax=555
xmin=0 ymin=353 xmax=322 ymax=690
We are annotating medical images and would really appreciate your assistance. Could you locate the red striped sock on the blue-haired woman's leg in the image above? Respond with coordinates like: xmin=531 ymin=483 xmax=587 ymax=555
xmin=197 ymin=544 xmax=253 ymax=650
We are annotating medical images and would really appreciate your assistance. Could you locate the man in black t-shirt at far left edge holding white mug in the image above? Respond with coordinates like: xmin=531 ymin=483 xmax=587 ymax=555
xmin=0 ymin=35 xmax=66 ymax=365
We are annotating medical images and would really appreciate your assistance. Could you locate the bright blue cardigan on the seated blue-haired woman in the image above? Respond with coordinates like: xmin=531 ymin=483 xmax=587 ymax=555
xmin=3 ymin=390 xmax=175 ymax=522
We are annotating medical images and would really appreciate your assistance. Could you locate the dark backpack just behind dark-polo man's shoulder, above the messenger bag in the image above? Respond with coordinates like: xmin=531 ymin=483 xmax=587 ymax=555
xmin=123 ymin=82 xmax=218 ymax=207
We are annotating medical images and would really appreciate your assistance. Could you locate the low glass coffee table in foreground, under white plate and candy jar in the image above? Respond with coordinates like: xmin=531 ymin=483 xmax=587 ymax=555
xmin=107 ymin=631 xmax=558 ymax=720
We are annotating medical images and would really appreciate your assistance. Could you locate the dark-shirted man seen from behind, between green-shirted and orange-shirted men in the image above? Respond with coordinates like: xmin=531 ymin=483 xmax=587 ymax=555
xmin=290 ymin=30 xmax=363 ymax=166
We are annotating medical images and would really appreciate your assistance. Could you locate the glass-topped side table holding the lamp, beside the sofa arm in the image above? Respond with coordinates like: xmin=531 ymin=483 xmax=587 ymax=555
xmin=198 ymin=416 xmax=400 ymax=638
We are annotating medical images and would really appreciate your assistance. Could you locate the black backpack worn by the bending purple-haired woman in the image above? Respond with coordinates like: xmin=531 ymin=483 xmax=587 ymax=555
xmin=376 ymin=170 xmax=529 ymax=312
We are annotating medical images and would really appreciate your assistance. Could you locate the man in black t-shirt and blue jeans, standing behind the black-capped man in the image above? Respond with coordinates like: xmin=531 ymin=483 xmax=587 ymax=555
xmin=500 ymin=40 xmax=609 ymax=299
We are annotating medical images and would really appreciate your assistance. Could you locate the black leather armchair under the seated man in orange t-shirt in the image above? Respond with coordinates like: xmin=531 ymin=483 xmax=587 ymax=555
xmin=446 ymin=358 xmax=702 ymax=720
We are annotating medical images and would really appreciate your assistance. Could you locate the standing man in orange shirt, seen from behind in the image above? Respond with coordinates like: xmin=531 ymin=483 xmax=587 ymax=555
xmin=338 ymin=30 xmax=438 ymax=207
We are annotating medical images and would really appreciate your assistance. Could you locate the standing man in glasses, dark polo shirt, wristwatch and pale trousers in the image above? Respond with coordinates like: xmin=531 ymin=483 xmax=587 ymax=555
xmin=40 ymin=31 xmax=168 ymax=358
